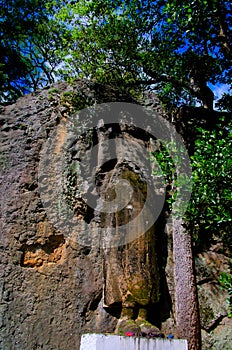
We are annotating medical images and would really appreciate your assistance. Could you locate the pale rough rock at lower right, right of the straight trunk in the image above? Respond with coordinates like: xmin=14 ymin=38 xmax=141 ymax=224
xmin=196 ymin=250 xmax=232 ymax=350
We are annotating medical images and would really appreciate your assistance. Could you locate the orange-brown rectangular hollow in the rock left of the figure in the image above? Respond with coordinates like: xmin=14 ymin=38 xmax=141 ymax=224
xmin=21 ymin=235 xmax=65 ymax=268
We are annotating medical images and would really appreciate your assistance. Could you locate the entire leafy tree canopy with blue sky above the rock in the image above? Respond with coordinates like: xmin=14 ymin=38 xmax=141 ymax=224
xmin=0 ymin=0 xmax=232 ymax=108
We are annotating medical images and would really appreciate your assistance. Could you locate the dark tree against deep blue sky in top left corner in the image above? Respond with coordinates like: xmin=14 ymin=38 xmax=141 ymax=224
xmin=0 ymin=0 xmax=65 ymax=103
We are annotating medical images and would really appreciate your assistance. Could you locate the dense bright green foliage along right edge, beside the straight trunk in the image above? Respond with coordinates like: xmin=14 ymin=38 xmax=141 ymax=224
xmin=186 ymin=116 xmax=232 ymax=250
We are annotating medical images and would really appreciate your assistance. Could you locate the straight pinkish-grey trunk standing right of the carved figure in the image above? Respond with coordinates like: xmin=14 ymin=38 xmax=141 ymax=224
xmin=173 ymin=218 xmax=201 ymax=350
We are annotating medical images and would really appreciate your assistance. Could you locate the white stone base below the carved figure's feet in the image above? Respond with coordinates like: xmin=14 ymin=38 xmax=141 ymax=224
xmin=80 ymin=334 xmax=188 ymax=350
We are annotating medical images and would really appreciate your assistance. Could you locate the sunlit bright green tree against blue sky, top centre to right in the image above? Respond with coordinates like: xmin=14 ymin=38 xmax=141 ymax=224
xmin=49 ymin=0 xmax=232 ymax=109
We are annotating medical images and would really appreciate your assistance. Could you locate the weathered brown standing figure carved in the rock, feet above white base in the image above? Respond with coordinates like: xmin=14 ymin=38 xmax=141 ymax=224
xmin=93 ymin=123 xmax=163 ymax=333
